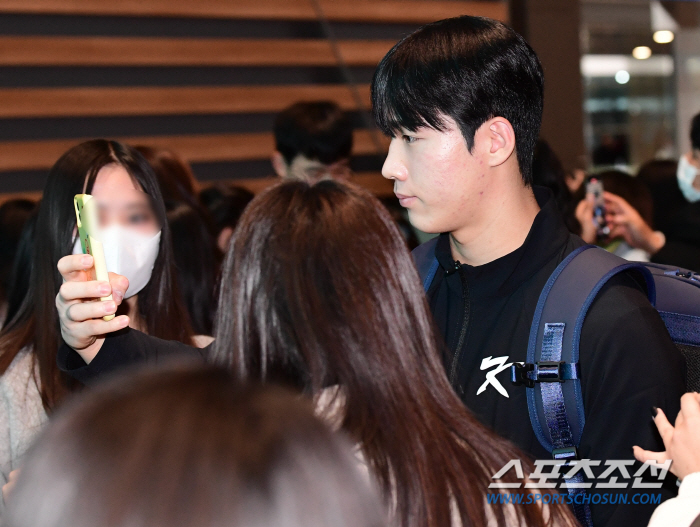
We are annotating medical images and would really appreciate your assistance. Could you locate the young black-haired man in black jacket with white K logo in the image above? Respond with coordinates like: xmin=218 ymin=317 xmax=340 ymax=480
xmin=372 ymin=16 xmax=685 ymax=527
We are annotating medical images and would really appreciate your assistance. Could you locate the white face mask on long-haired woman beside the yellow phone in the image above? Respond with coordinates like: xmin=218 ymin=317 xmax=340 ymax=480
xmin=73 ymin=224 xmax=161 ymax=298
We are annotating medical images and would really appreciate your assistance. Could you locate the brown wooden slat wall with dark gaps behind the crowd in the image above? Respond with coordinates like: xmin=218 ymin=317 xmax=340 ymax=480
xmin=0 ymin=0 xmax=506 ymax=200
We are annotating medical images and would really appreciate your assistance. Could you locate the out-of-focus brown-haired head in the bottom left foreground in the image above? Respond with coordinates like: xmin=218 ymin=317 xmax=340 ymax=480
xmin=4 ymin=367 xmax=386 ymax=527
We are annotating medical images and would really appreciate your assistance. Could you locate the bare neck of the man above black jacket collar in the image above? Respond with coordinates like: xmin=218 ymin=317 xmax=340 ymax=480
xmin=450 ymin=173 xmax=540 ymax=266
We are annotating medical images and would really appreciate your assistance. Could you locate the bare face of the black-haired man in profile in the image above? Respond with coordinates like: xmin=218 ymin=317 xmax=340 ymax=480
xmin=382 ymin=118 xmax=489 ymax=233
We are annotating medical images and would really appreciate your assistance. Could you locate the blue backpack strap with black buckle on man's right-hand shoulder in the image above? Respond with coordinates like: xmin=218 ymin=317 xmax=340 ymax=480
xmin=511 ymin=245 xmax=655 ymax=525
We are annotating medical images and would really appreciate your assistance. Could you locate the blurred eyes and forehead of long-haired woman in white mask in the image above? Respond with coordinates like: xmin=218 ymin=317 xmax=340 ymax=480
xmin=92 ymin=164 xmax=160 ymax=235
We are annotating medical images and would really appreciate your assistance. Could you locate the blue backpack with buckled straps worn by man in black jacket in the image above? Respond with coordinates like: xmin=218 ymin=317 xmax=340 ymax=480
xmin=413 ymin=238 xmax=700 ymax=527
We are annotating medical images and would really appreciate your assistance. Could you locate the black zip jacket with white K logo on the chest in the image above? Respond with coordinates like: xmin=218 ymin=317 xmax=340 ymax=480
xmin=428 ymin=189 xmax=685 ymax=527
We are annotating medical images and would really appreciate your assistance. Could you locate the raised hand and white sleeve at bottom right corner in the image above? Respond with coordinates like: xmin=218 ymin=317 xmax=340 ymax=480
xmin=634 ymin=393 xmax=700 ymax=527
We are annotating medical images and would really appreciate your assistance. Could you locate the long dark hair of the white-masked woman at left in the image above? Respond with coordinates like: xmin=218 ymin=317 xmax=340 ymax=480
xmin=0 ymin=139 xmax=192 ymax=412
